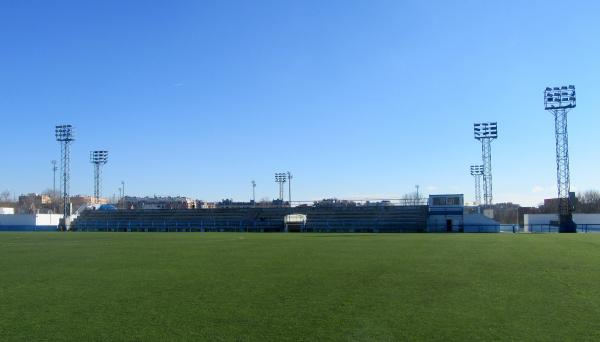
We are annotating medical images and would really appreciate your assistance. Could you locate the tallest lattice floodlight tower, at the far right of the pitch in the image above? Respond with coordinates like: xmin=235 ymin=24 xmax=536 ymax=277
xmin=544 ymin=85 xmax=577 ymax=233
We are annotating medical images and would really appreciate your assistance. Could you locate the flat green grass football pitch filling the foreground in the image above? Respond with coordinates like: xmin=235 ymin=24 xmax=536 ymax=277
xmin=0 ymin=233 xmax=600 ymax=341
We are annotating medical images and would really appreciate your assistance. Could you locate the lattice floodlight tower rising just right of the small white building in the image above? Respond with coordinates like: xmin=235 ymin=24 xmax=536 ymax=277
xmin=473 ymin=122 xmax=498 ymax=205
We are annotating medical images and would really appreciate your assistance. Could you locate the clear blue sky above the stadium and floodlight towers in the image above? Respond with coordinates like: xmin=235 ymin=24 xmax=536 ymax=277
xmin=0 ymin=0 xmax=600 ymax=204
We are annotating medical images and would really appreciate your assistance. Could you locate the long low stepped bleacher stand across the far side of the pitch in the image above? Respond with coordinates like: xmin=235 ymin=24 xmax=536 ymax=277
xmin=72 ymin=206 xmax=427 ymax=233
